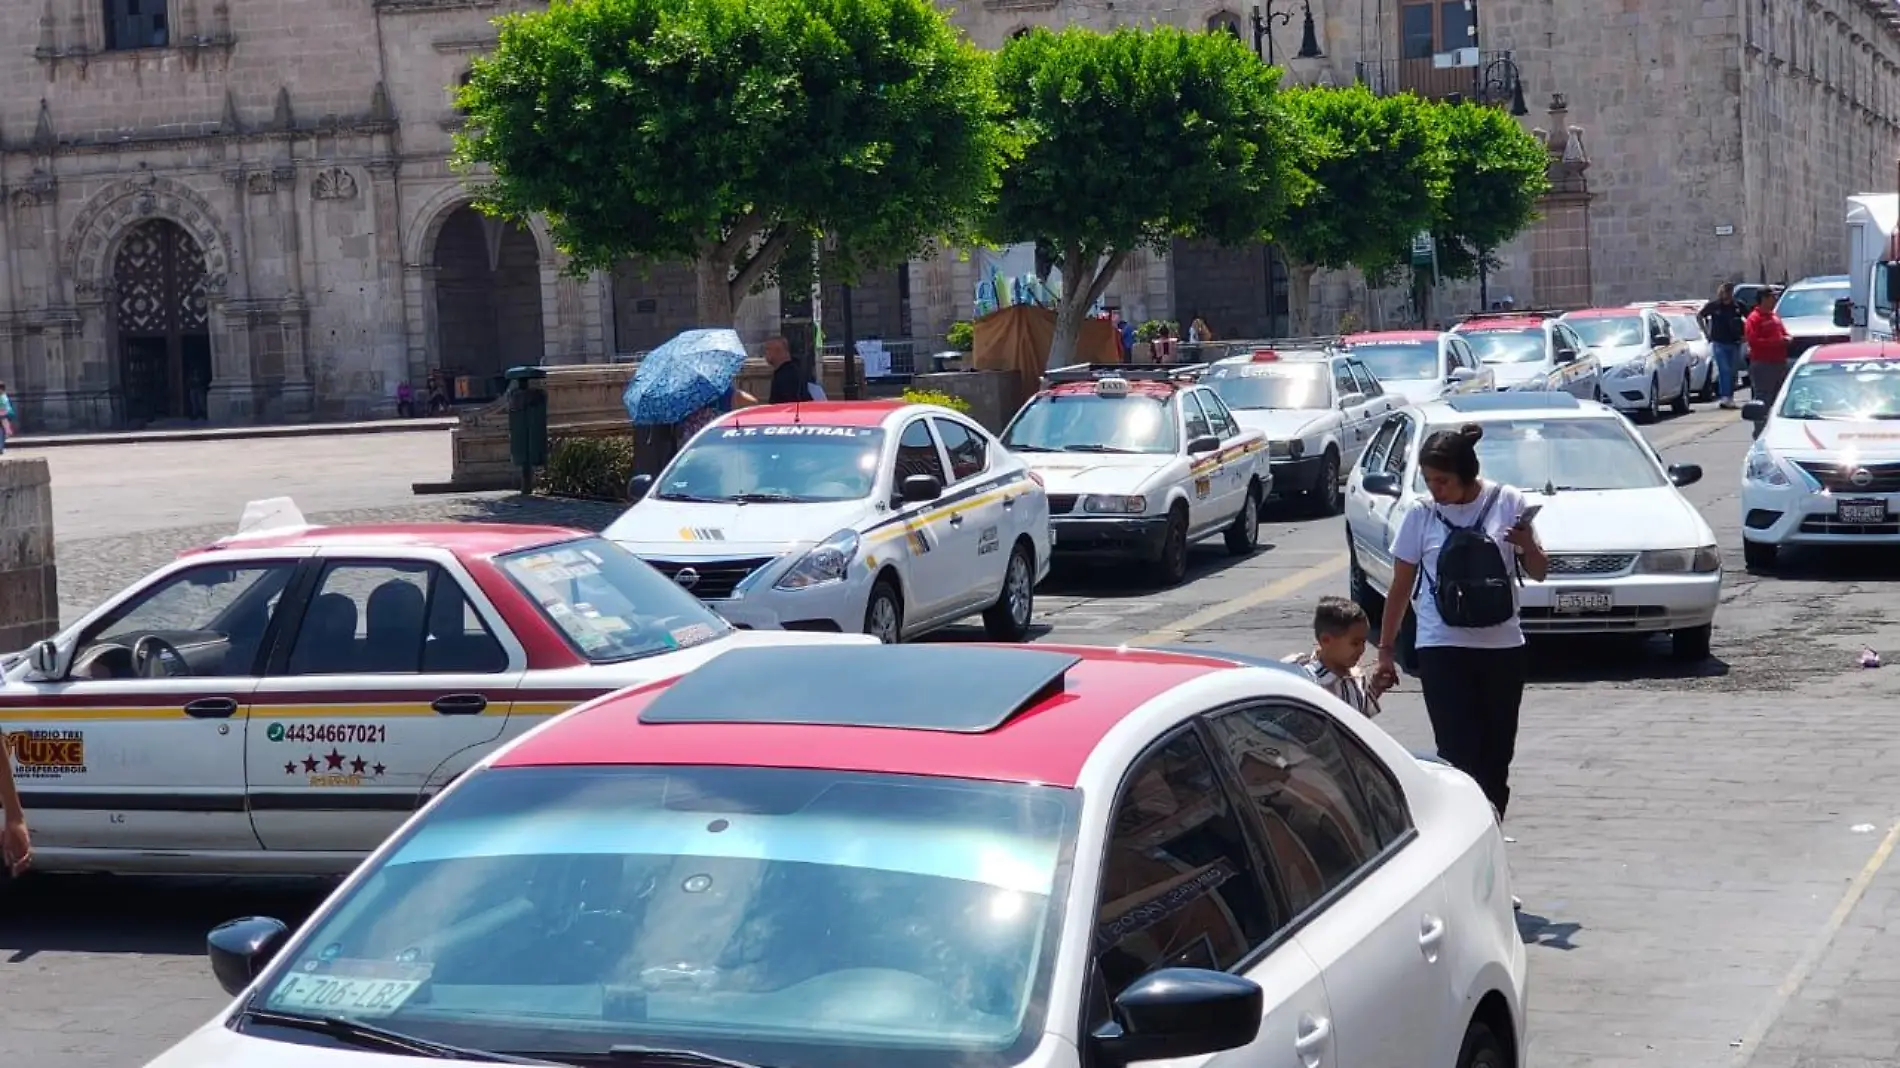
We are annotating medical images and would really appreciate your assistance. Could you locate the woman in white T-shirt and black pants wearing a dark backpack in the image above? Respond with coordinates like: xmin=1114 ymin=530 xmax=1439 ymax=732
xmin=1374 ymin=424 xmax=1550 ymax=821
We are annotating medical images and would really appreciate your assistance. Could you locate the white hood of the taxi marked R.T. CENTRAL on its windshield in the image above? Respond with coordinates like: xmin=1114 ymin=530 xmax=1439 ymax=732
xmin=602 ymin=500 xmax=870 ymax=561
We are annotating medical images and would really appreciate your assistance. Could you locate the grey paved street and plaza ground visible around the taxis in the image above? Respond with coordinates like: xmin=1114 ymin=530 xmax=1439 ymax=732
xmin=11 ymin=402 xmax=1900 ymax=1068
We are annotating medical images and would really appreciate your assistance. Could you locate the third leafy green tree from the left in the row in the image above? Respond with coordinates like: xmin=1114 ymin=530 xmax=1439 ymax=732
xmin=1273 ymin=86 xmax=1450 ymax=333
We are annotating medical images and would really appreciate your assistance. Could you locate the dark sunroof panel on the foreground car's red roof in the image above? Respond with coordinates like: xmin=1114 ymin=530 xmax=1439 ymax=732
xmin=640 ymin=644 xmax=1081 ymax=734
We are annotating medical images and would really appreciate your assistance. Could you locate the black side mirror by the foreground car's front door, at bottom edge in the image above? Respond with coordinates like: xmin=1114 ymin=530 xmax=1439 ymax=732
xmin=1089 ymin=967 xmax=1265 ymax=1066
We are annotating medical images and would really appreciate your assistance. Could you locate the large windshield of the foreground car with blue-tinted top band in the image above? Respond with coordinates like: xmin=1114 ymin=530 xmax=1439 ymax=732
xmin=245 ymin=766 xmax=1077 ymax=1068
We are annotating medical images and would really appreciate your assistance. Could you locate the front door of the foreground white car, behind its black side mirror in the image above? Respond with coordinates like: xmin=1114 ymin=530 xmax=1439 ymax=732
xmin=1079 ymin=726 xmax=1345 ymax=1068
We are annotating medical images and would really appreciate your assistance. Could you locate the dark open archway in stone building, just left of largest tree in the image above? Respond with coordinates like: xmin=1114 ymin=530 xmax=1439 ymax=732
xmin=435 ymin=207 xmax=543 ymax=401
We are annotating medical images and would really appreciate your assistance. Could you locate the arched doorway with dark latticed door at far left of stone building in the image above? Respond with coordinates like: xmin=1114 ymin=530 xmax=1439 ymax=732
xmin=112 ymin=219 xmax=211 ymax=424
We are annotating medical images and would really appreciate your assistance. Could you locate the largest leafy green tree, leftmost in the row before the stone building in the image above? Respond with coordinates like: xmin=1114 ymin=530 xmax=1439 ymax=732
xmin=456 ymin=0 xmax=1007 ymax=323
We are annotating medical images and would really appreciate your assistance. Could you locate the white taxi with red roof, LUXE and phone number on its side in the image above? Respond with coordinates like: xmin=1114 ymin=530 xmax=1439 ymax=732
xmin=0 ymin=500 xmax=862 ymax=874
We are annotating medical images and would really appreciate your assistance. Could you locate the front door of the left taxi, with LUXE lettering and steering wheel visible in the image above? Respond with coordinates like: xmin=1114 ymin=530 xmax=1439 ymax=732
xmin=0 ymin=553 xmax=308 ymax=851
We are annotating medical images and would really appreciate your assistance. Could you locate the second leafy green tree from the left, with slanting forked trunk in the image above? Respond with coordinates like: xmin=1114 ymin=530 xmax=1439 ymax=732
xmin=988 ymin=27 xmax=1303 ymax=365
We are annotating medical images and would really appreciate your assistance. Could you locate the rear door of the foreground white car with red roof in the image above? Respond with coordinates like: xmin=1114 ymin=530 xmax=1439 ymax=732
xmin=1210 ymin=699 xmax=1465 ymax=1064
